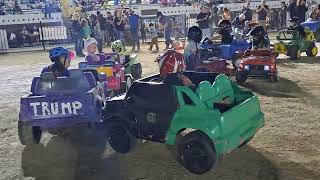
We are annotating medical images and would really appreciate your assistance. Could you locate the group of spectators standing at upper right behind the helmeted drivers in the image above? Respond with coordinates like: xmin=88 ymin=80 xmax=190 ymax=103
xmin=197 ymin=0 xmax=320 ymax=36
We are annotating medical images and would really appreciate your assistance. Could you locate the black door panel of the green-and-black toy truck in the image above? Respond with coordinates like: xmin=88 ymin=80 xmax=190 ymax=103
xmin=127 ymin=82 xmax=178 ymax=142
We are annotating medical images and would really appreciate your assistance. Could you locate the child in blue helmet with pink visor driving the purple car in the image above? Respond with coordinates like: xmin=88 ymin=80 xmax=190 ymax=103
xmin=41 ymin=47 xmax=73 ymax=77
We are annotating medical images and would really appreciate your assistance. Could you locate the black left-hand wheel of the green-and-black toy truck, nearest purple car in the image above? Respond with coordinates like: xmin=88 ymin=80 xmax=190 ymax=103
xmin=106 ymin=122 xmax=136 ymax=154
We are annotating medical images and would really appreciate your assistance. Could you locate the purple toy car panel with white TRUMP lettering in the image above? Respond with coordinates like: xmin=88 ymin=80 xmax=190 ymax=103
xmin=19 ymin=93 xmax=102 ymax=129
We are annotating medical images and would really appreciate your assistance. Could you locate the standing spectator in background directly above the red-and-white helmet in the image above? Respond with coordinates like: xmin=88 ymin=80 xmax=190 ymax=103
xmin=157 ymin=12 xmax=173 ymax=50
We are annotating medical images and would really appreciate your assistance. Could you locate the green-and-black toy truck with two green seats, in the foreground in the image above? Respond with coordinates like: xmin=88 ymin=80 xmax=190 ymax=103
xmin=104 ymin=72 xmax=264 ymax=174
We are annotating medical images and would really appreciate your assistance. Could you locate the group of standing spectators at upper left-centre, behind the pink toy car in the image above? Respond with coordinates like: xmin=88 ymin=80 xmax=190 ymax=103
xmin=70 ymin=8 xmax=183 ymax=56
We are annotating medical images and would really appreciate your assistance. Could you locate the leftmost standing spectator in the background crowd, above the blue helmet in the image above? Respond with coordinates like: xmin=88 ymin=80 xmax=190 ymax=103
xmin=71 ymin=13 xmax=84 ymax=57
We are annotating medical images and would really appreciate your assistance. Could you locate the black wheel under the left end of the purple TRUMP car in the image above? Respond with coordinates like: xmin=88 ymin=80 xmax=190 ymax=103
xmin=18 ymin=121 xmax=42 ymax=145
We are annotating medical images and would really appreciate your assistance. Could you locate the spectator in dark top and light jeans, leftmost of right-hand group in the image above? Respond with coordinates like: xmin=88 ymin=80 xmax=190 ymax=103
xmin=197 ymin=5 xmax=211 ymax=39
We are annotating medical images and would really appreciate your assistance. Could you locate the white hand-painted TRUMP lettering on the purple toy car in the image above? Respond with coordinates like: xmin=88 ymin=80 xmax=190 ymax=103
xmin=30 ymin=101 xmax=82 ymax=116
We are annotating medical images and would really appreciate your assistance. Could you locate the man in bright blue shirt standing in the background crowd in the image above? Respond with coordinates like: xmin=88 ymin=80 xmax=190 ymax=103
xmin=128 ymin=9 xmax=140 ymax=51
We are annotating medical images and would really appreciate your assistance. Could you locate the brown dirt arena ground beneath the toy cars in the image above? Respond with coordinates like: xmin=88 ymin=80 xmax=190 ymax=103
xmin=0 ymin=43 xmax=320 ymax=180
